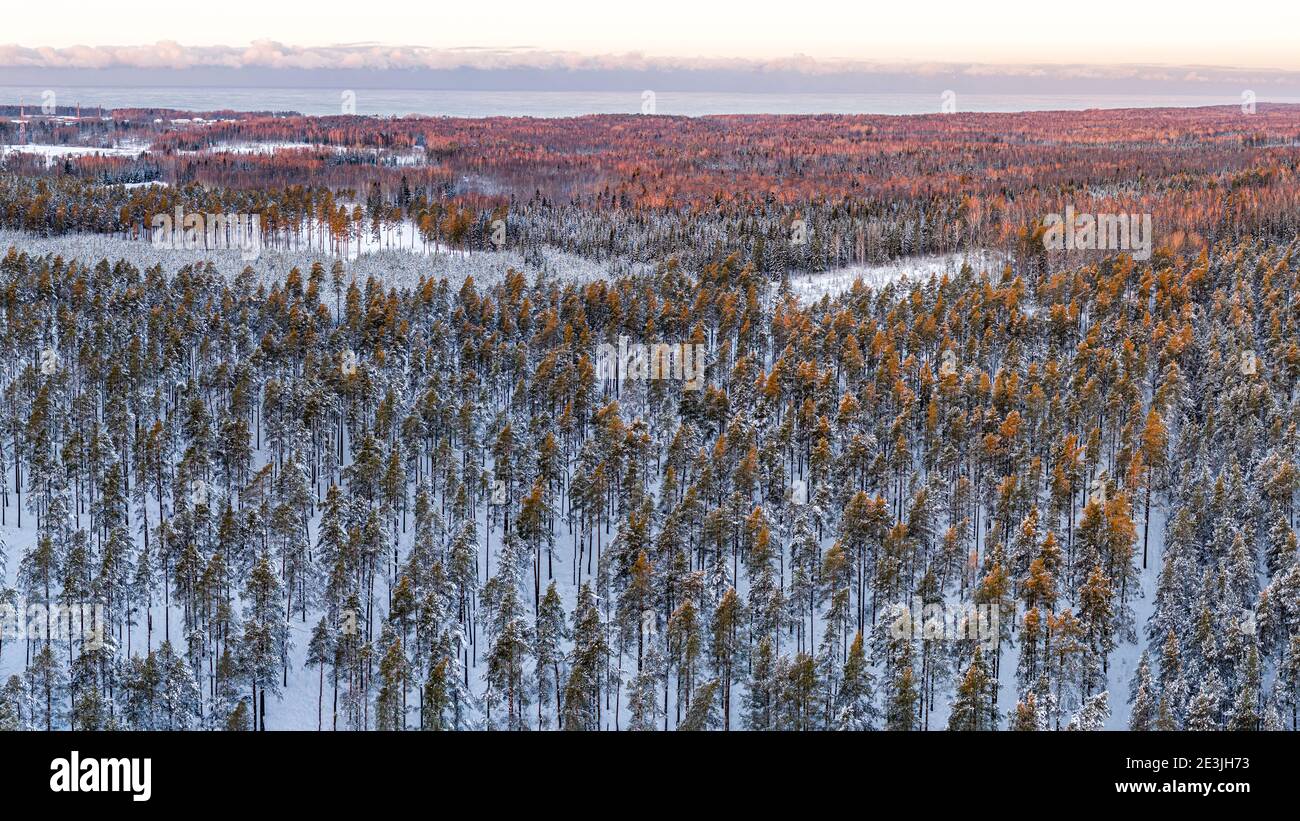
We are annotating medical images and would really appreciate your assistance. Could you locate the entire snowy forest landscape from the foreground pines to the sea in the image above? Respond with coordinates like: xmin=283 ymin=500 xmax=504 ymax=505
xmin=0 ymin=99 xmax=1300 ymax=731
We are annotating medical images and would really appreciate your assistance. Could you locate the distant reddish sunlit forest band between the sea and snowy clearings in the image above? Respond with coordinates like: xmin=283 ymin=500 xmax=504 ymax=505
xmin=0 ymin=105 xmax=1300 ymax=273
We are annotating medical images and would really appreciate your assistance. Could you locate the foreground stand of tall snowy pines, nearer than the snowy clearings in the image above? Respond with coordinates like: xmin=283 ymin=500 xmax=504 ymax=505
xmin=0 ymin=227 xmax=1300 ymax=730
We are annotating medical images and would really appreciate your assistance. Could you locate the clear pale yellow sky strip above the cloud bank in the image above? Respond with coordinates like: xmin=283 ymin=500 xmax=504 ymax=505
xmin=0 ymin=0 xmax=1300 ymax=69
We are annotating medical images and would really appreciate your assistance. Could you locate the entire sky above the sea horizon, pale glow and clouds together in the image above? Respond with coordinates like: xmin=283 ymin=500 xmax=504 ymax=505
xmin=0 ymin=0 xmax=1300 ymax=94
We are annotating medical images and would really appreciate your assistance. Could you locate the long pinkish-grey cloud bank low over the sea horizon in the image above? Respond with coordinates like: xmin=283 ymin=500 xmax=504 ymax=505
xmin=0 ymin=40 xmax=1300 ymax=96
